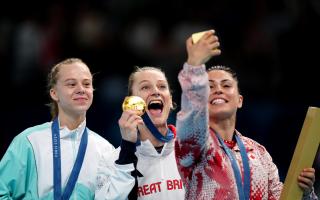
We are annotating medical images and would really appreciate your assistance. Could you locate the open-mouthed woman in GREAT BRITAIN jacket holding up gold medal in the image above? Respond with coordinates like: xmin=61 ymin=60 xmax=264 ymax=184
xmin=119 ymin=67 xmax=185 ymax=200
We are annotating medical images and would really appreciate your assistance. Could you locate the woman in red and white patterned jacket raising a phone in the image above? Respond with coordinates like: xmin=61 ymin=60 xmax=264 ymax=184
xmin=176 ymin=31 xmax=317 ymax=200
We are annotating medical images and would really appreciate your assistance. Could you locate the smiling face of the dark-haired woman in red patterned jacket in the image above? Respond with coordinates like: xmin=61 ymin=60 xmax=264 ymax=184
xmin=208 ymin=70 xmax=243 ymax=120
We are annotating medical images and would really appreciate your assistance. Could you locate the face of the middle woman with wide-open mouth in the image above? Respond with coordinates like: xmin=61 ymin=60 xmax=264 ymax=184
xmin=129 ymin=68 xmax=172 ymax=126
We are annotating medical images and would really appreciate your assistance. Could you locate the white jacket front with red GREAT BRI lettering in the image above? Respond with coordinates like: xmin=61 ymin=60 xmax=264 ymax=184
xmin=136 ymin=127 xmax=185 ymax=200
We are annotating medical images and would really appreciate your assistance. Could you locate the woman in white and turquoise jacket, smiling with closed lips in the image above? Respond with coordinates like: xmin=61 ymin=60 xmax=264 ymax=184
xmin=0 ymin=58 xmax=134 ymax=200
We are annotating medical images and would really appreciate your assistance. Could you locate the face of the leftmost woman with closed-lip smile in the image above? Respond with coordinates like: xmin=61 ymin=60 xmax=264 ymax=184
xmin=50 ymin=62 xmax=93 ymax=117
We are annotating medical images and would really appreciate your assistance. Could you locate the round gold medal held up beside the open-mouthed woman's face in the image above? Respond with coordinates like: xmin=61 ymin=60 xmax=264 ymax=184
xmin=122 ymin=96 xmax=146 ymax=116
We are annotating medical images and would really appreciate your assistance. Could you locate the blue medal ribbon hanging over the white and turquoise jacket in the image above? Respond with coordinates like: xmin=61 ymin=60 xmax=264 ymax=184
xmin=51 ymin=118 xmax=88 ymax=200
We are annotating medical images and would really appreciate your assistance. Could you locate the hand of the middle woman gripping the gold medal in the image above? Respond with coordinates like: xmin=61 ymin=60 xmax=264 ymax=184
xmin=118 ymin=110 xmax=144 ymax=143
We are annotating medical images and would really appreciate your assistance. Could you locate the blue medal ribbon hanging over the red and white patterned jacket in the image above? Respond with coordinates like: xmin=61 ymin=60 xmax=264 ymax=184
xmin=213 ymin=130 xmax=250 ymax=200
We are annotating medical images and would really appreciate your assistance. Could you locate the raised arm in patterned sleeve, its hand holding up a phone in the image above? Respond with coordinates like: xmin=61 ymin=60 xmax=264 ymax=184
xmin=176 ymin=31 xmax=220 ymax=179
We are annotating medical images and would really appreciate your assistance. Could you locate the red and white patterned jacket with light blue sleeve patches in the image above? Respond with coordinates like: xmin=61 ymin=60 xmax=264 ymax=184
xmin=175 ymin=64 xmax=317 ymax=200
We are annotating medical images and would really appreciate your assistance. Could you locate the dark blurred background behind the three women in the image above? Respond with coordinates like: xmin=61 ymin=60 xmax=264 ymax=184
xmin=0 ymin=0 xmax=320 ymax=194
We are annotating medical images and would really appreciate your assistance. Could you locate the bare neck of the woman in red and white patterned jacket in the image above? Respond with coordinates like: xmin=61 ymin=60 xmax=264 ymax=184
xmin=209 ymin=115 xmax=235 ymax=141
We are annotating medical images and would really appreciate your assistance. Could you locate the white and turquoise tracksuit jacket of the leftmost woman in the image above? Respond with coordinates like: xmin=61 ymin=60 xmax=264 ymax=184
xmin=0 ymin=121 xmax=134 ymax=200
